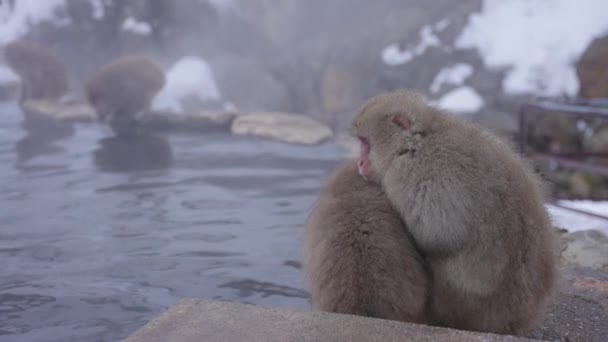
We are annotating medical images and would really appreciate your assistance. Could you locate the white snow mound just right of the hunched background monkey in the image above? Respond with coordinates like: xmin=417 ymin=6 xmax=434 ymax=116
xmin=152 ymin=56 xmax=220 ymax=113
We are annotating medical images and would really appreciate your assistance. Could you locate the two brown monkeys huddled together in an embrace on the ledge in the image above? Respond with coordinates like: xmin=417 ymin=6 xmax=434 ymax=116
xmin=303 ymin=91 xmax=558 ymax=335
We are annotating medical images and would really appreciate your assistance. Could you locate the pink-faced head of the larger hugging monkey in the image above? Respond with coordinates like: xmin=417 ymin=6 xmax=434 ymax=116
xmin=353 ymin=91 xmax=439 ymax=182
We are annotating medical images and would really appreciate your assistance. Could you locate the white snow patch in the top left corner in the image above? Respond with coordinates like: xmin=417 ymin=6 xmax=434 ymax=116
xmin=0 ymin=0 xmax=65 ymax=44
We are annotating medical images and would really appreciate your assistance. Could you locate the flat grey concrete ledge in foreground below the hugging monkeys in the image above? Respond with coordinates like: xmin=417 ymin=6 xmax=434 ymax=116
xmin=125 ymin=299 xmax=530 ymax=342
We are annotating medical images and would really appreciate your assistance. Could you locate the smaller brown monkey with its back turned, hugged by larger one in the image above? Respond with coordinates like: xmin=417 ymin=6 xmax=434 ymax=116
xmin=302 ymin=160 xmax=427 ymax=323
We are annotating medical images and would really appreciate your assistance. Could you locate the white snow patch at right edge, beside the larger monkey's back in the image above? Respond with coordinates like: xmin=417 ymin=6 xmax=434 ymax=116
xmin=546 ymin=201 xmax=608 ymax=235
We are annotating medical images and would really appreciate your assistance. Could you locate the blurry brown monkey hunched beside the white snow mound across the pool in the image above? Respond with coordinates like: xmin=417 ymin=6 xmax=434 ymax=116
xmin=86 ymin=56 xmax=166 ymax=129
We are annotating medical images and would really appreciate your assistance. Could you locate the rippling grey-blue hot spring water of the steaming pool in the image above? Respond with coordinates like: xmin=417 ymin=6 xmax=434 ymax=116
xmin=0 ymin=104 xmax=342 ymax=341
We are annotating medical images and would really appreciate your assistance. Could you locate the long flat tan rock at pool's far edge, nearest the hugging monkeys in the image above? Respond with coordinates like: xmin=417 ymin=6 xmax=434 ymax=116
xmin=231 ymin=112 xmax=333 ymax=145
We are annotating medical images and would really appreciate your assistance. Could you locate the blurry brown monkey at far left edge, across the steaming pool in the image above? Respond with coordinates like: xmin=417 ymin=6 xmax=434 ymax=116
xmin=4 ymin=41 xmax=69 ymax=103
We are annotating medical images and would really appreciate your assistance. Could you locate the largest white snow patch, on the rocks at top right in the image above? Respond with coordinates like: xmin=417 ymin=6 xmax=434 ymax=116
xmin=456 ymin=0 xmax=608 ymax=96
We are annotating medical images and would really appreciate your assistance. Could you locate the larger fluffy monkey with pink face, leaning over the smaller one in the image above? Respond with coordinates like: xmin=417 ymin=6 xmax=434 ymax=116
xmin=353 ymin=91 xmax=557 ymax=335
